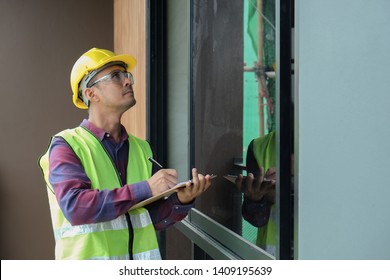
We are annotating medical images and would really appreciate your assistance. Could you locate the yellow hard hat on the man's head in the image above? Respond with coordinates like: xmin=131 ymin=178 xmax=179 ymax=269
xmin=70 ymin=48 xmax=137 ymax=109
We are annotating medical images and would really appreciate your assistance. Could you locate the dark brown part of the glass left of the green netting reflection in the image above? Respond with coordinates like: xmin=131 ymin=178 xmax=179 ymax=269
xmin=190 ymin=0 xmax=244 ymax=235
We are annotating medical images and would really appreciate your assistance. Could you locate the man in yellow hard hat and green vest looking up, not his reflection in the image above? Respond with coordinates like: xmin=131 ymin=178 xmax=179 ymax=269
xmin=39 ymin=48 xmax=211 ymax=259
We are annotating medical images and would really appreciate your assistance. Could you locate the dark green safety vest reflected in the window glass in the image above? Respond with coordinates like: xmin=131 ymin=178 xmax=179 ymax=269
xmin=253 ymin=132 xmax=277 ymax=256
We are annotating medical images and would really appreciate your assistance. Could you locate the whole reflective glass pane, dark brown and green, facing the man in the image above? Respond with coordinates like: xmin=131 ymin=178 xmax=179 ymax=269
xmin=190 ymin=0 xmax=276 ymax=254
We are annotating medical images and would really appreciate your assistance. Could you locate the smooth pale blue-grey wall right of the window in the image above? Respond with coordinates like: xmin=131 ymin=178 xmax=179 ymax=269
xmin=295 ymin=0 xmax=390 ymax=259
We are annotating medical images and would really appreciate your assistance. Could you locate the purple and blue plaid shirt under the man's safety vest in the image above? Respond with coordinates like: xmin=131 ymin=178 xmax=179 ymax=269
xmin=49 ymin=120 xmax=194 ymax=230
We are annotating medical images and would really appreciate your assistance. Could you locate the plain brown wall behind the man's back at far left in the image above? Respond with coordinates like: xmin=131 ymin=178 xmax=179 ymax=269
xmin=0 ymin=0 xmax=113 ymax=259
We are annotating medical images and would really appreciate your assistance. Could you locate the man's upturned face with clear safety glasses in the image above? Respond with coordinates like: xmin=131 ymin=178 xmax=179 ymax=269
xmin=91 ymin=65 xmax=136 ymax=112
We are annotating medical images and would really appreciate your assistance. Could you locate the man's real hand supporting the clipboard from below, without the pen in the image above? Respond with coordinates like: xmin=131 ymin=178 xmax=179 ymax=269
xmin=177 ymin=168 xmax=211 ymax=204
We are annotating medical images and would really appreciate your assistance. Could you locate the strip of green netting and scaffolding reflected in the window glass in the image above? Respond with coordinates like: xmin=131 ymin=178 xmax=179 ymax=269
xmin=242 ymin=0 xmax=276 ymax=255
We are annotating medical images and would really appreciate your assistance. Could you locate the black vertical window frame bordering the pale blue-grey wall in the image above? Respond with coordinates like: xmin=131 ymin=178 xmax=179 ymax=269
xmin=276 ymin=0 xmax=294 ymax=260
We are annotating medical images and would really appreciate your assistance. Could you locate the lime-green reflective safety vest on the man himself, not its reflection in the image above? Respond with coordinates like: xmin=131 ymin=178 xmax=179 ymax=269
xmin=39 ymin=127 xmax=161 ymax=260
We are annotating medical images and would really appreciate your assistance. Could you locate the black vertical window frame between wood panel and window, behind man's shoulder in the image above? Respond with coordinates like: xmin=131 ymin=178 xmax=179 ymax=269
xmin=146 ymin=0 xmax=168 ymax=256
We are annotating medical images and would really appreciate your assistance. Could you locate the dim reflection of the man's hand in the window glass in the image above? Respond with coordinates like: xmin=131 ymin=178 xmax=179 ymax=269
xmin=235 ymin=167 xmax=276 ymax=203
